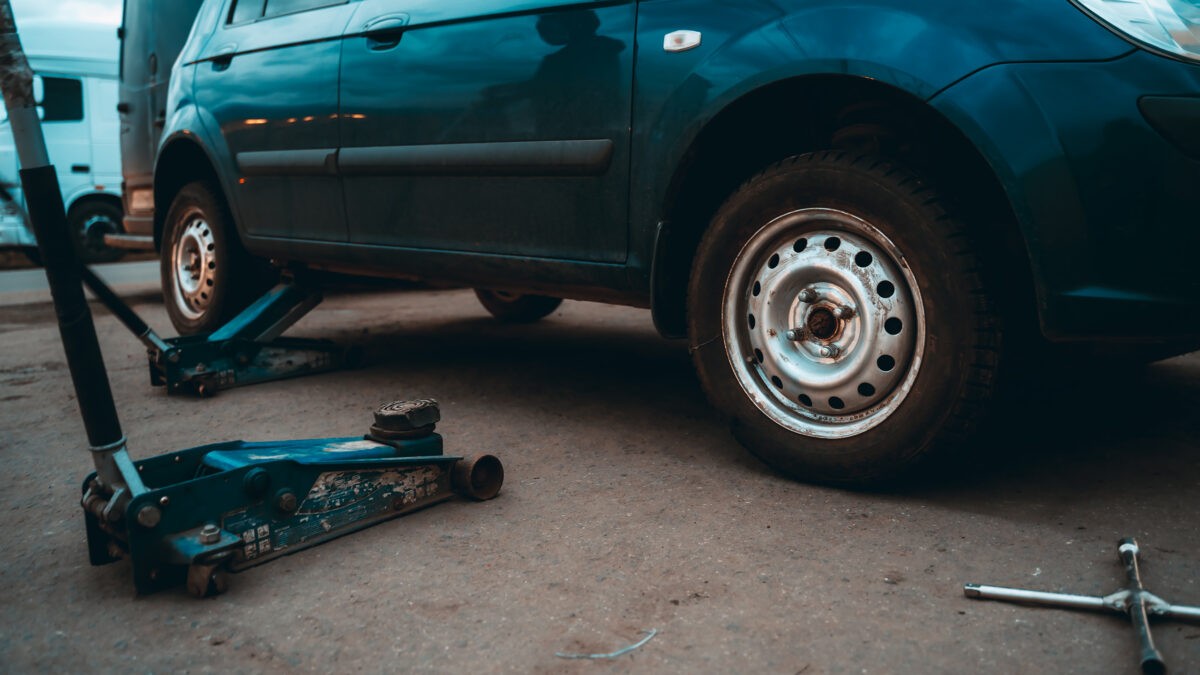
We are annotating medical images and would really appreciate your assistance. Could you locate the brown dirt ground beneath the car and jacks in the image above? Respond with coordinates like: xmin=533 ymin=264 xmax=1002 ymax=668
xmin=0 ymin=281 xmax=1200 ymax=675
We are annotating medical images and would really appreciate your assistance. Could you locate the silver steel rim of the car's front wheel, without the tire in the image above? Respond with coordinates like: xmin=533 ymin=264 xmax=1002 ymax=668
xmin=721 ymin=208 xmax=925 ymax=438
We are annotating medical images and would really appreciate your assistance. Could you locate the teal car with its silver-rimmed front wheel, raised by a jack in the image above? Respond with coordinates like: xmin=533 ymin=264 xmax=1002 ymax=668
xmin=147 ymin=0 xmax=1200 ymax=482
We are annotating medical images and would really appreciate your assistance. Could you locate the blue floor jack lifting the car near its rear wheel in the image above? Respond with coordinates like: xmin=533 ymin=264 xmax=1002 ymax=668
xmin=80 ymin=268 xmax=348 ymax=396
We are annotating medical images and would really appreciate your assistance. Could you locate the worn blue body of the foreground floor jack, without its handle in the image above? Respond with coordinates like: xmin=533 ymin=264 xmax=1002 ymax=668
xmin=82 ymin=399 xmax=504 ymax=597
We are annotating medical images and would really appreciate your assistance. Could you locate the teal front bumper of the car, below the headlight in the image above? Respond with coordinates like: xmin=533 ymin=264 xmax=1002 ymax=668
xmin=932 ymin=52 xmax=1200 ymax=338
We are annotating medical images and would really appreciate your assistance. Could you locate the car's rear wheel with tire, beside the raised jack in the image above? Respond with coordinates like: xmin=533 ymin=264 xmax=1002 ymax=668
xmin=160 ymin=181 xmax=270 ymax=335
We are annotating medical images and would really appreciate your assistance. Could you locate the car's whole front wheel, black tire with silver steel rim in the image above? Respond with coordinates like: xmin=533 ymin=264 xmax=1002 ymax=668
xmin=688 ymin=151 xmax=1001 ymax=485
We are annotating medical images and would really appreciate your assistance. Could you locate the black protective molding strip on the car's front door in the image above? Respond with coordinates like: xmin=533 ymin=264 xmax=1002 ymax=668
xmin=337 ymin=138 xmax=613 ymax=175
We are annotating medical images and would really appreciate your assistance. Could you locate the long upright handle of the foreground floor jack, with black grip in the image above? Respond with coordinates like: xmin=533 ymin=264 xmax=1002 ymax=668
xmin=0 ymin=0 xmax=145 ymax=511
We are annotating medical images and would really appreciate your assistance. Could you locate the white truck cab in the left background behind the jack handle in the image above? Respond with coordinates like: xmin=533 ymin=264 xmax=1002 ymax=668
xmin=0 ymin=19 xmax=122 ymax=262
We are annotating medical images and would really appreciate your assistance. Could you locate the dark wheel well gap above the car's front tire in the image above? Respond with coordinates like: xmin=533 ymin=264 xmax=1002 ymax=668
xmin=650 ymin=74 xmax=1037 ymax=338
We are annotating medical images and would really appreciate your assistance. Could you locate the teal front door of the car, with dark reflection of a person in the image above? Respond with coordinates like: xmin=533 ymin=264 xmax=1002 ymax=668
xmin=338 ymin=0 xmax=636 ymax=262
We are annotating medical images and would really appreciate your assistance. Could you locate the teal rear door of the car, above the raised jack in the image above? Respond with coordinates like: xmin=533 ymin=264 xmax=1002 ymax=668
xmin=194 ymin=0 xmax=356 ymax=241
